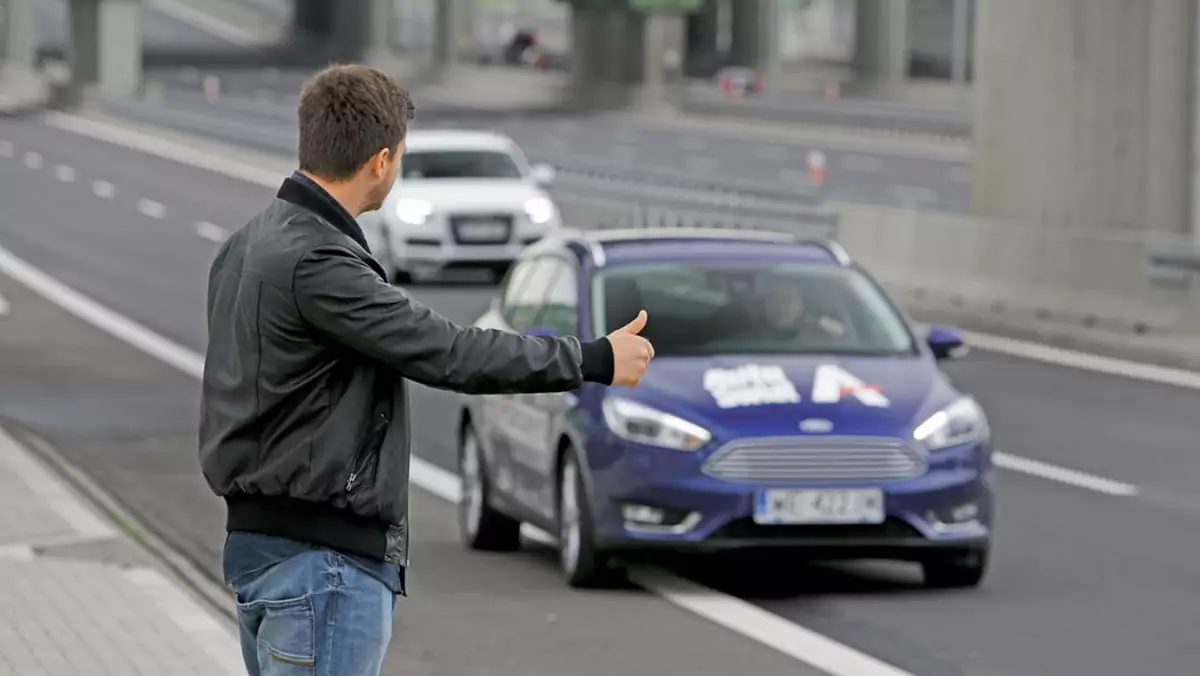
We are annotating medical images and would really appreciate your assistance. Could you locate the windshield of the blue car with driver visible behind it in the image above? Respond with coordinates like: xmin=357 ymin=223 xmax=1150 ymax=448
xmin=592 ymin=261 xmax=917 ymax=355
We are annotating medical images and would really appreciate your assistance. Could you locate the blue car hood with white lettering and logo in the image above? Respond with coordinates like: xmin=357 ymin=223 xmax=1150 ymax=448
xmin=611 ymin=357 xmax=958 ymax=438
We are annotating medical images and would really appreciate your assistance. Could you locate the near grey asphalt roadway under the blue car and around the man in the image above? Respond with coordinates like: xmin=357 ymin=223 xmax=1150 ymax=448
xmin=0 ymin=113 xmax=1200 ymax=676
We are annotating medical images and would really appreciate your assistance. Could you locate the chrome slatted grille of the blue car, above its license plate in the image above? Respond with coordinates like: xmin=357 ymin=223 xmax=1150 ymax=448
xmin=703 ymin=437 xmax=925 ymax=484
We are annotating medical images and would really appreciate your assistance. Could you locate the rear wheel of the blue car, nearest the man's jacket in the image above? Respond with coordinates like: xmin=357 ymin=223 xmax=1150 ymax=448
xmin=457 ymin=423 xmax=521 ymax=551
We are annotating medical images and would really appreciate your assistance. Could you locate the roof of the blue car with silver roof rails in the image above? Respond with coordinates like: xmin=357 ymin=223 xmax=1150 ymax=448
xmin=529 ymin=228 xmax=853 ymax=267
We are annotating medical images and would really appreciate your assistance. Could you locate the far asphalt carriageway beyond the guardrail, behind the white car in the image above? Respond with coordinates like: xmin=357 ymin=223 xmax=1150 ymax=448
xmin=113 ymin=81 xmax=970 ymax=211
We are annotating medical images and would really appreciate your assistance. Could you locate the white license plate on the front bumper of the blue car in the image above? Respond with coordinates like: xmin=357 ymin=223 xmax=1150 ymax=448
xmin=754 ymin=489 xmax=884 ymax=525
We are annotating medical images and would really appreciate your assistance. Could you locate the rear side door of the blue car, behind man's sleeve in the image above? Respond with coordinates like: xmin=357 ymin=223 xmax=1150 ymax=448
xmin=488 ymin=256 xmax=558 ymax=513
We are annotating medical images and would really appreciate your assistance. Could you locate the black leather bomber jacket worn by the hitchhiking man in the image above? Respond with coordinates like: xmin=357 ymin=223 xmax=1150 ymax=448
xmin=199 ymin=178 xmax=613 ymax=566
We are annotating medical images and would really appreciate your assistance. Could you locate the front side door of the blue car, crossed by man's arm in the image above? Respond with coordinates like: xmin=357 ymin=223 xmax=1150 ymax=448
xmin=521 ymin=257 xmax=580 ymax=522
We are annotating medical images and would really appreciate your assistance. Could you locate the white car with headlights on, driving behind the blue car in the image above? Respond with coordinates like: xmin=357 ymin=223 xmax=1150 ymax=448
xmin=359 ymin=130 xmax=562 ymax=283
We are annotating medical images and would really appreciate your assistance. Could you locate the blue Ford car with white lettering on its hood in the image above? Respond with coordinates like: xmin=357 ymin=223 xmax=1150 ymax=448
xmin=458 ymin=228 xmax=992 ymax=587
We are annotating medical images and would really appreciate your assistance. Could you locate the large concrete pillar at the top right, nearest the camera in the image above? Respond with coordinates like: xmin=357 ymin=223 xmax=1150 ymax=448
xmin=971 ymin=0 xmax=1196 ymax=232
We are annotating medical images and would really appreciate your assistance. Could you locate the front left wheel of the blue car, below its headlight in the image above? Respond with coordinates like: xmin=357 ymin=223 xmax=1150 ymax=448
xmin=557 ymin=449 xmax=614 ymax=588
